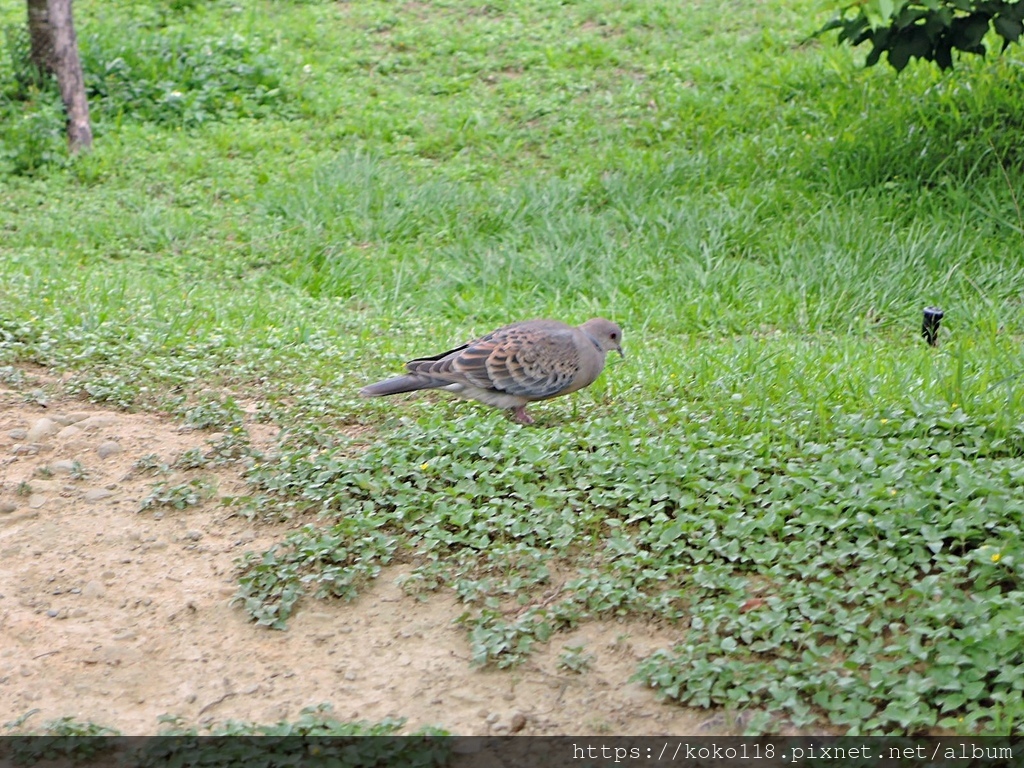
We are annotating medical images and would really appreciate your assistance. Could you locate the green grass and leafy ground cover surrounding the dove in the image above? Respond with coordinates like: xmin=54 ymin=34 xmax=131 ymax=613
xmin=0 ymin=0 xmax=1024 ymax=734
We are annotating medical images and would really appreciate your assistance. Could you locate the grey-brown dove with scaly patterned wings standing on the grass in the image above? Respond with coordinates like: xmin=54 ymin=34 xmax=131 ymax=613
xmin=359 ymin=317 xmax=626 ymax=424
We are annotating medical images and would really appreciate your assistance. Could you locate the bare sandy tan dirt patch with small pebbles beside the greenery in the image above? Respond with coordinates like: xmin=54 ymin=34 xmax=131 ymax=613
xmin=0 ymin=372 xmax=732 ymax=735
